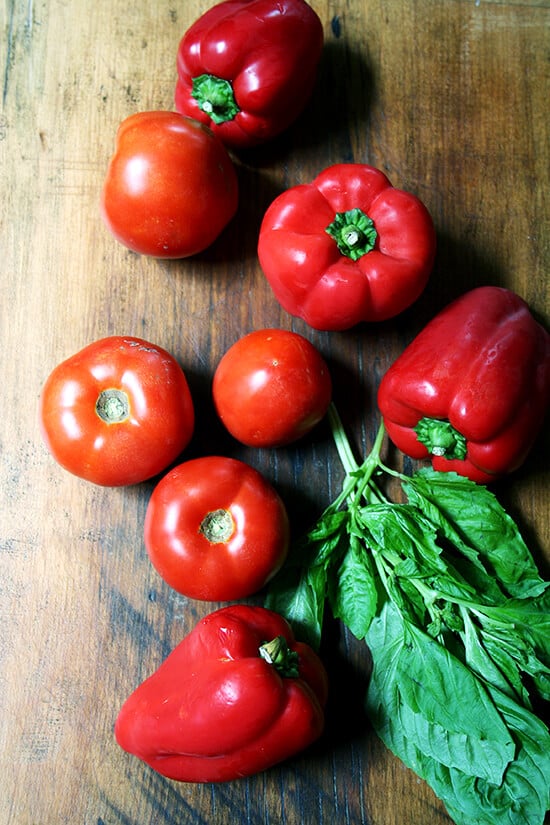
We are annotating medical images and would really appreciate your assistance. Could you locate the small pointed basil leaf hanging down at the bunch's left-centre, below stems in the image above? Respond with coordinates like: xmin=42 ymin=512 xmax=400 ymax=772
xmin=329 ymin=536 xmax=378 ymax=639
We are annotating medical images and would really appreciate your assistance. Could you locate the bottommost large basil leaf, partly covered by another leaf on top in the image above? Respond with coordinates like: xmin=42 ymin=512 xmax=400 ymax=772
xmin=366 ymin=604 xmax=550 ymax=825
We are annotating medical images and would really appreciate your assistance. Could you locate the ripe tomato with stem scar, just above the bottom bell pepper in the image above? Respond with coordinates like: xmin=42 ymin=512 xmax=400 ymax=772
xmin=144 ymin=456 xmax=289 ymax=601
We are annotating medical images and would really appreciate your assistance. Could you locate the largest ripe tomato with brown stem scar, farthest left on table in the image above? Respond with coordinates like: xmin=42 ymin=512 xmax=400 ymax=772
xmin=40 ymin=336 xmax=194 ymax=487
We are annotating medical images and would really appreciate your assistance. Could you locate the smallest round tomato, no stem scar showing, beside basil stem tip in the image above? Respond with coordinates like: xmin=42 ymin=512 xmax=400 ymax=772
xmin=212 ymin=329 xmax=332 ymax=447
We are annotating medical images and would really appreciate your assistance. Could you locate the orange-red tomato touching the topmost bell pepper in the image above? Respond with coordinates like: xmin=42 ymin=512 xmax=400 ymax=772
xmin=101 ymin=112 xmax=238 ymax=258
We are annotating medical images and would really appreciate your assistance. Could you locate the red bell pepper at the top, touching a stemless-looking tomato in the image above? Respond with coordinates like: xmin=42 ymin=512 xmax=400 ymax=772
xmin=175 ymin=0 xmax=323 ymax=148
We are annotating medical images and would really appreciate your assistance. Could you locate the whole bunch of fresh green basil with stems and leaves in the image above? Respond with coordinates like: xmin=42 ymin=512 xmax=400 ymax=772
xmin=266 ymin=407 xmax=550 ymax=825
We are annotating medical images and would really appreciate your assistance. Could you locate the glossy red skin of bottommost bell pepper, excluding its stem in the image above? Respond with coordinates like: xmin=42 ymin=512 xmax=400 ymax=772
xmin=115 ymin=605 xmax=327 ymax=782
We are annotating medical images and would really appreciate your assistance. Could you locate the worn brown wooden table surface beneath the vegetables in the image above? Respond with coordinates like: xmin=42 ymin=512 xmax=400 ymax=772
xmin=0 ymin=0 xmax=550 ymax=825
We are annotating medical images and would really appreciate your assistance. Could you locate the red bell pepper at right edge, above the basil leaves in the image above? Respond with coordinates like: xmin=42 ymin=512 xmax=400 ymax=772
xmin=378 ymin=286 xmax=550 ymax=483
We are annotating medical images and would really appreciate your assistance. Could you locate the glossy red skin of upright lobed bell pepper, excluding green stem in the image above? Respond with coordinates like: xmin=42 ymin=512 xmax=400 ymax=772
xmin=258 ymin=163 xmax=436 ymax=330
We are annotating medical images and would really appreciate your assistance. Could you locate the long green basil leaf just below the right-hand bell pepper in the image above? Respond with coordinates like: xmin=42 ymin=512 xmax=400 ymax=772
xmin=403 ymin=468 xmax=547 ymax=598
